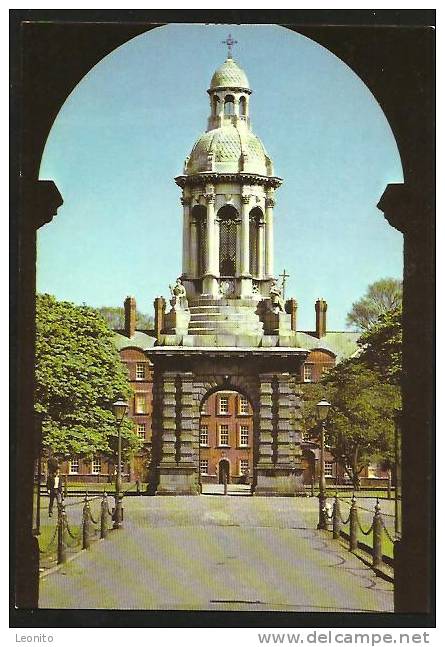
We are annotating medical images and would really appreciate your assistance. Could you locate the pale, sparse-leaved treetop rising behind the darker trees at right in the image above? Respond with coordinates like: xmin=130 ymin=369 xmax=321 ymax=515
xmin=346 ymin=278 xmax=403 ymax=330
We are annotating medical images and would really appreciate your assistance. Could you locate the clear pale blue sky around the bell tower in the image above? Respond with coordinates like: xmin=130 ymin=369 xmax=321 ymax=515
xmin=37 ymin=25 xmax=403 ymax=330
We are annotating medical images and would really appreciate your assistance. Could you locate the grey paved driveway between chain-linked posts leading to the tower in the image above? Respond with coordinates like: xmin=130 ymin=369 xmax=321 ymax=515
xmin=40 ymin=495 xmax=393 ymax=612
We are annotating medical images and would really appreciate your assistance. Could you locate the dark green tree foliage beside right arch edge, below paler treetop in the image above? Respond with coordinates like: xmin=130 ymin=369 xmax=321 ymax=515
xmin=358 ymin=307 xmax=402 ymax=385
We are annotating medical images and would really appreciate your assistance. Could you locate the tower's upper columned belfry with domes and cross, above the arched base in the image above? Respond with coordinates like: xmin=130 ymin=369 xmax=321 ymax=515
xmin=175 ymin=36 xmax=282 ymax=334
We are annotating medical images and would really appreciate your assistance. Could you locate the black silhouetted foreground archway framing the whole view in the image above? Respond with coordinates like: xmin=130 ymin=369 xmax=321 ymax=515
xmin=11 ymin=10 xmax=435 ymax=626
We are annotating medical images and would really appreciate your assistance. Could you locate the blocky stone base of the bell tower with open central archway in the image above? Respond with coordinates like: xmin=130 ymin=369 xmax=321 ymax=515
xmin=147 ymin=346 xmax=307 ymax=496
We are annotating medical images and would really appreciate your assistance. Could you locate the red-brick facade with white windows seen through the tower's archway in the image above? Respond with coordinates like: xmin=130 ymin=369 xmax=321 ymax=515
xmin=199 ymin=390 xmax=254 ymax=494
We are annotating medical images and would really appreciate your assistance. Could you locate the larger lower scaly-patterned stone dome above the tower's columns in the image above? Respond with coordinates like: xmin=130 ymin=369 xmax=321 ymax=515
xmin=185 ymin=123 xmax=271 ymax=175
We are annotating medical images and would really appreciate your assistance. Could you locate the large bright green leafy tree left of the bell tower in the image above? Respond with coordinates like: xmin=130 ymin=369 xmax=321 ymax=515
xmin=35 ymin=294 xmax=141 ymax=459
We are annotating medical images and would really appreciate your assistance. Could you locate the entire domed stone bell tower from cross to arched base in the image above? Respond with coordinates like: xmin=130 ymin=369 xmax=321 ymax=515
xmin=147 ymin=46 xmax=308 ymax=496
